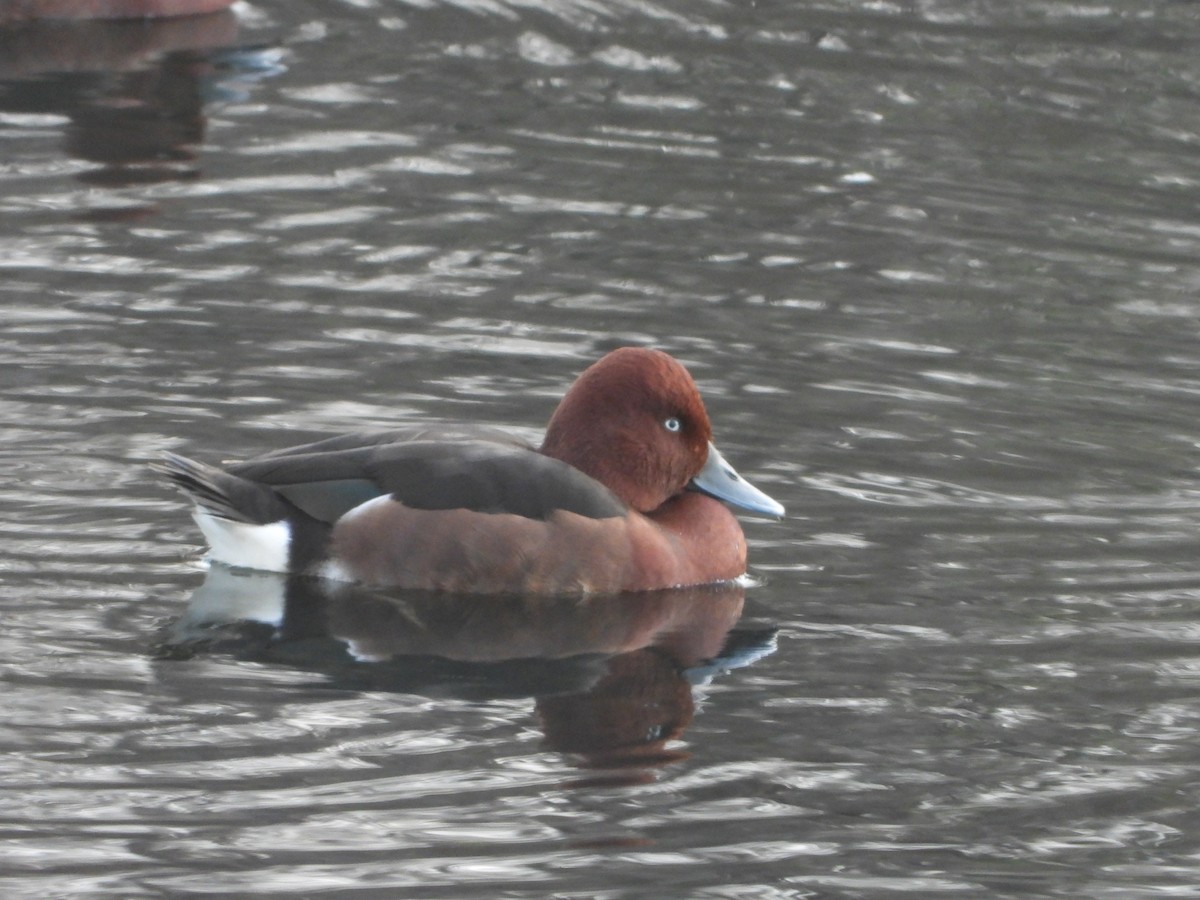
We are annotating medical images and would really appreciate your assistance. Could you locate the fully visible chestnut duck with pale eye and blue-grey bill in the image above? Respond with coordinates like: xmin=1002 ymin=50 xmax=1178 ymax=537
xmin=156 ymin=347 xmax=784 ymax=594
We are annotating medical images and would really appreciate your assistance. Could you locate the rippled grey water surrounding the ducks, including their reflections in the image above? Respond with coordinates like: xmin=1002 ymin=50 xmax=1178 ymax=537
xmin=0 ymin=0 xmax=1200 ymax=898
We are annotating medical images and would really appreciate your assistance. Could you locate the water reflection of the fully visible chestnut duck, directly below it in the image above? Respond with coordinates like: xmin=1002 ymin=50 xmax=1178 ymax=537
xmin=160 ymin=573 xmax=774 ymax=786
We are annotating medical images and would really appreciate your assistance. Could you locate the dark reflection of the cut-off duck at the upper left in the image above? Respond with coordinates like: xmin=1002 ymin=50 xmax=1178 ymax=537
xmin=0 ymin=7 xmax=281 ymax=221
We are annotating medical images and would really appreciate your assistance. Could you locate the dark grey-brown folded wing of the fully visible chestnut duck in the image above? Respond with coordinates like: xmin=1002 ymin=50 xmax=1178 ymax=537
xmin=228 ymin=438 xmax=628 ymax=522
